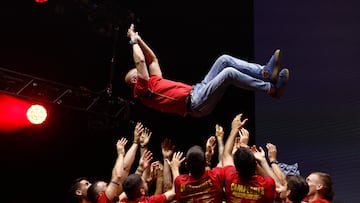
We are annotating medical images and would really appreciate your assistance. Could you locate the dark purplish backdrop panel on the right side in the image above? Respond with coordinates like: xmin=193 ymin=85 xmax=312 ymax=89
xmin=254 ymin=0 xmax=360 ymax=203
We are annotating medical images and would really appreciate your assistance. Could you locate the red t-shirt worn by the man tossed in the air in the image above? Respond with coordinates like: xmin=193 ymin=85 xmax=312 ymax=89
xmin=134 ymin=75 xmax=192 ymax=116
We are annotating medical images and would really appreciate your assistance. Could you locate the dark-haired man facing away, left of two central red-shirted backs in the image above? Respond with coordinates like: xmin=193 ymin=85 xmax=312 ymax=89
xmin=174 ymin=145 xmax=224 ymax=202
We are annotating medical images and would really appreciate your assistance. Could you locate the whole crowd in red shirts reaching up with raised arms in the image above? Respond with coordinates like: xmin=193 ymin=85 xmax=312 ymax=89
xmin=69 ymin=114 xmax=334 ymax=203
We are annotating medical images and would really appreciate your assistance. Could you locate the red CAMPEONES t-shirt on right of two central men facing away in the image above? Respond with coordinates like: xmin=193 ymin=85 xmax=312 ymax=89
xmin=224 ymin=166 xmax=276 ymax=203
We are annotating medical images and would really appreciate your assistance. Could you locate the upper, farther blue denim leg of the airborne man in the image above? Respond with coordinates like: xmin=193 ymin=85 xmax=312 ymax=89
xmin=202 ymin=54 xmax=266 ymax=84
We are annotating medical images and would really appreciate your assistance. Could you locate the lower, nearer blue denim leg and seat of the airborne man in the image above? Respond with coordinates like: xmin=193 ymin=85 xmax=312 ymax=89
xmin=191 ymin=66 xmax=271 ymax=117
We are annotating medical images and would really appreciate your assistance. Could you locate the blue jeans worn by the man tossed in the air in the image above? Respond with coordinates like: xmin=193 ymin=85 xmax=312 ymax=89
xmin=190 ymin=55 xmax=271 ymax=117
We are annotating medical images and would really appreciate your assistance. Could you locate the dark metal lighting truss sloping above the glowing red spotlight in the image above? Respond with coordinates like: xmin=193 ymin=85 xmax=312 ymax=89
xmin=0 ymin=68 xmax=132 ymax=123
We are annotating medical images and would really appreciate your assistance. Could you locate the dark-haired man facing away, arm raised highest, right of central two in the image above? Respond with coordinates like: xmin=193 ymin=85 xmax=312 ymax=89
xmin=223 ymin=114 xmax=276 ymax=203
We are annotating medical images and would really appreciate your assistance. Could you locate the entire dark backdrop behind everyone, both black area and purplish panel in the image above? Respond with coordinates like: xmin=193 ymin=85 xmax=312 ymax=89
xmin=0 ymin=0 xmax=360 ymax=202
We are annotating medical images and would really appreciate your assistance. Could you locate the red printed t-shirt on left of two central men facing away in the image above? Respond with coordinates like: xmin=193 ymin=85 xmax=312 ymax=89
xmin=174 ymin=167 xmax=224 ymax=203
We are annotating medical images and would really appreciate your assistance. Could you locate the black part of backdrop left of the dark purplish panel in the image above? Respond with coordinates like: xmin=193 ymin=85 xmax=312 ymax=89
xmin=0 ymin=0 xmax=253 ymax=202
